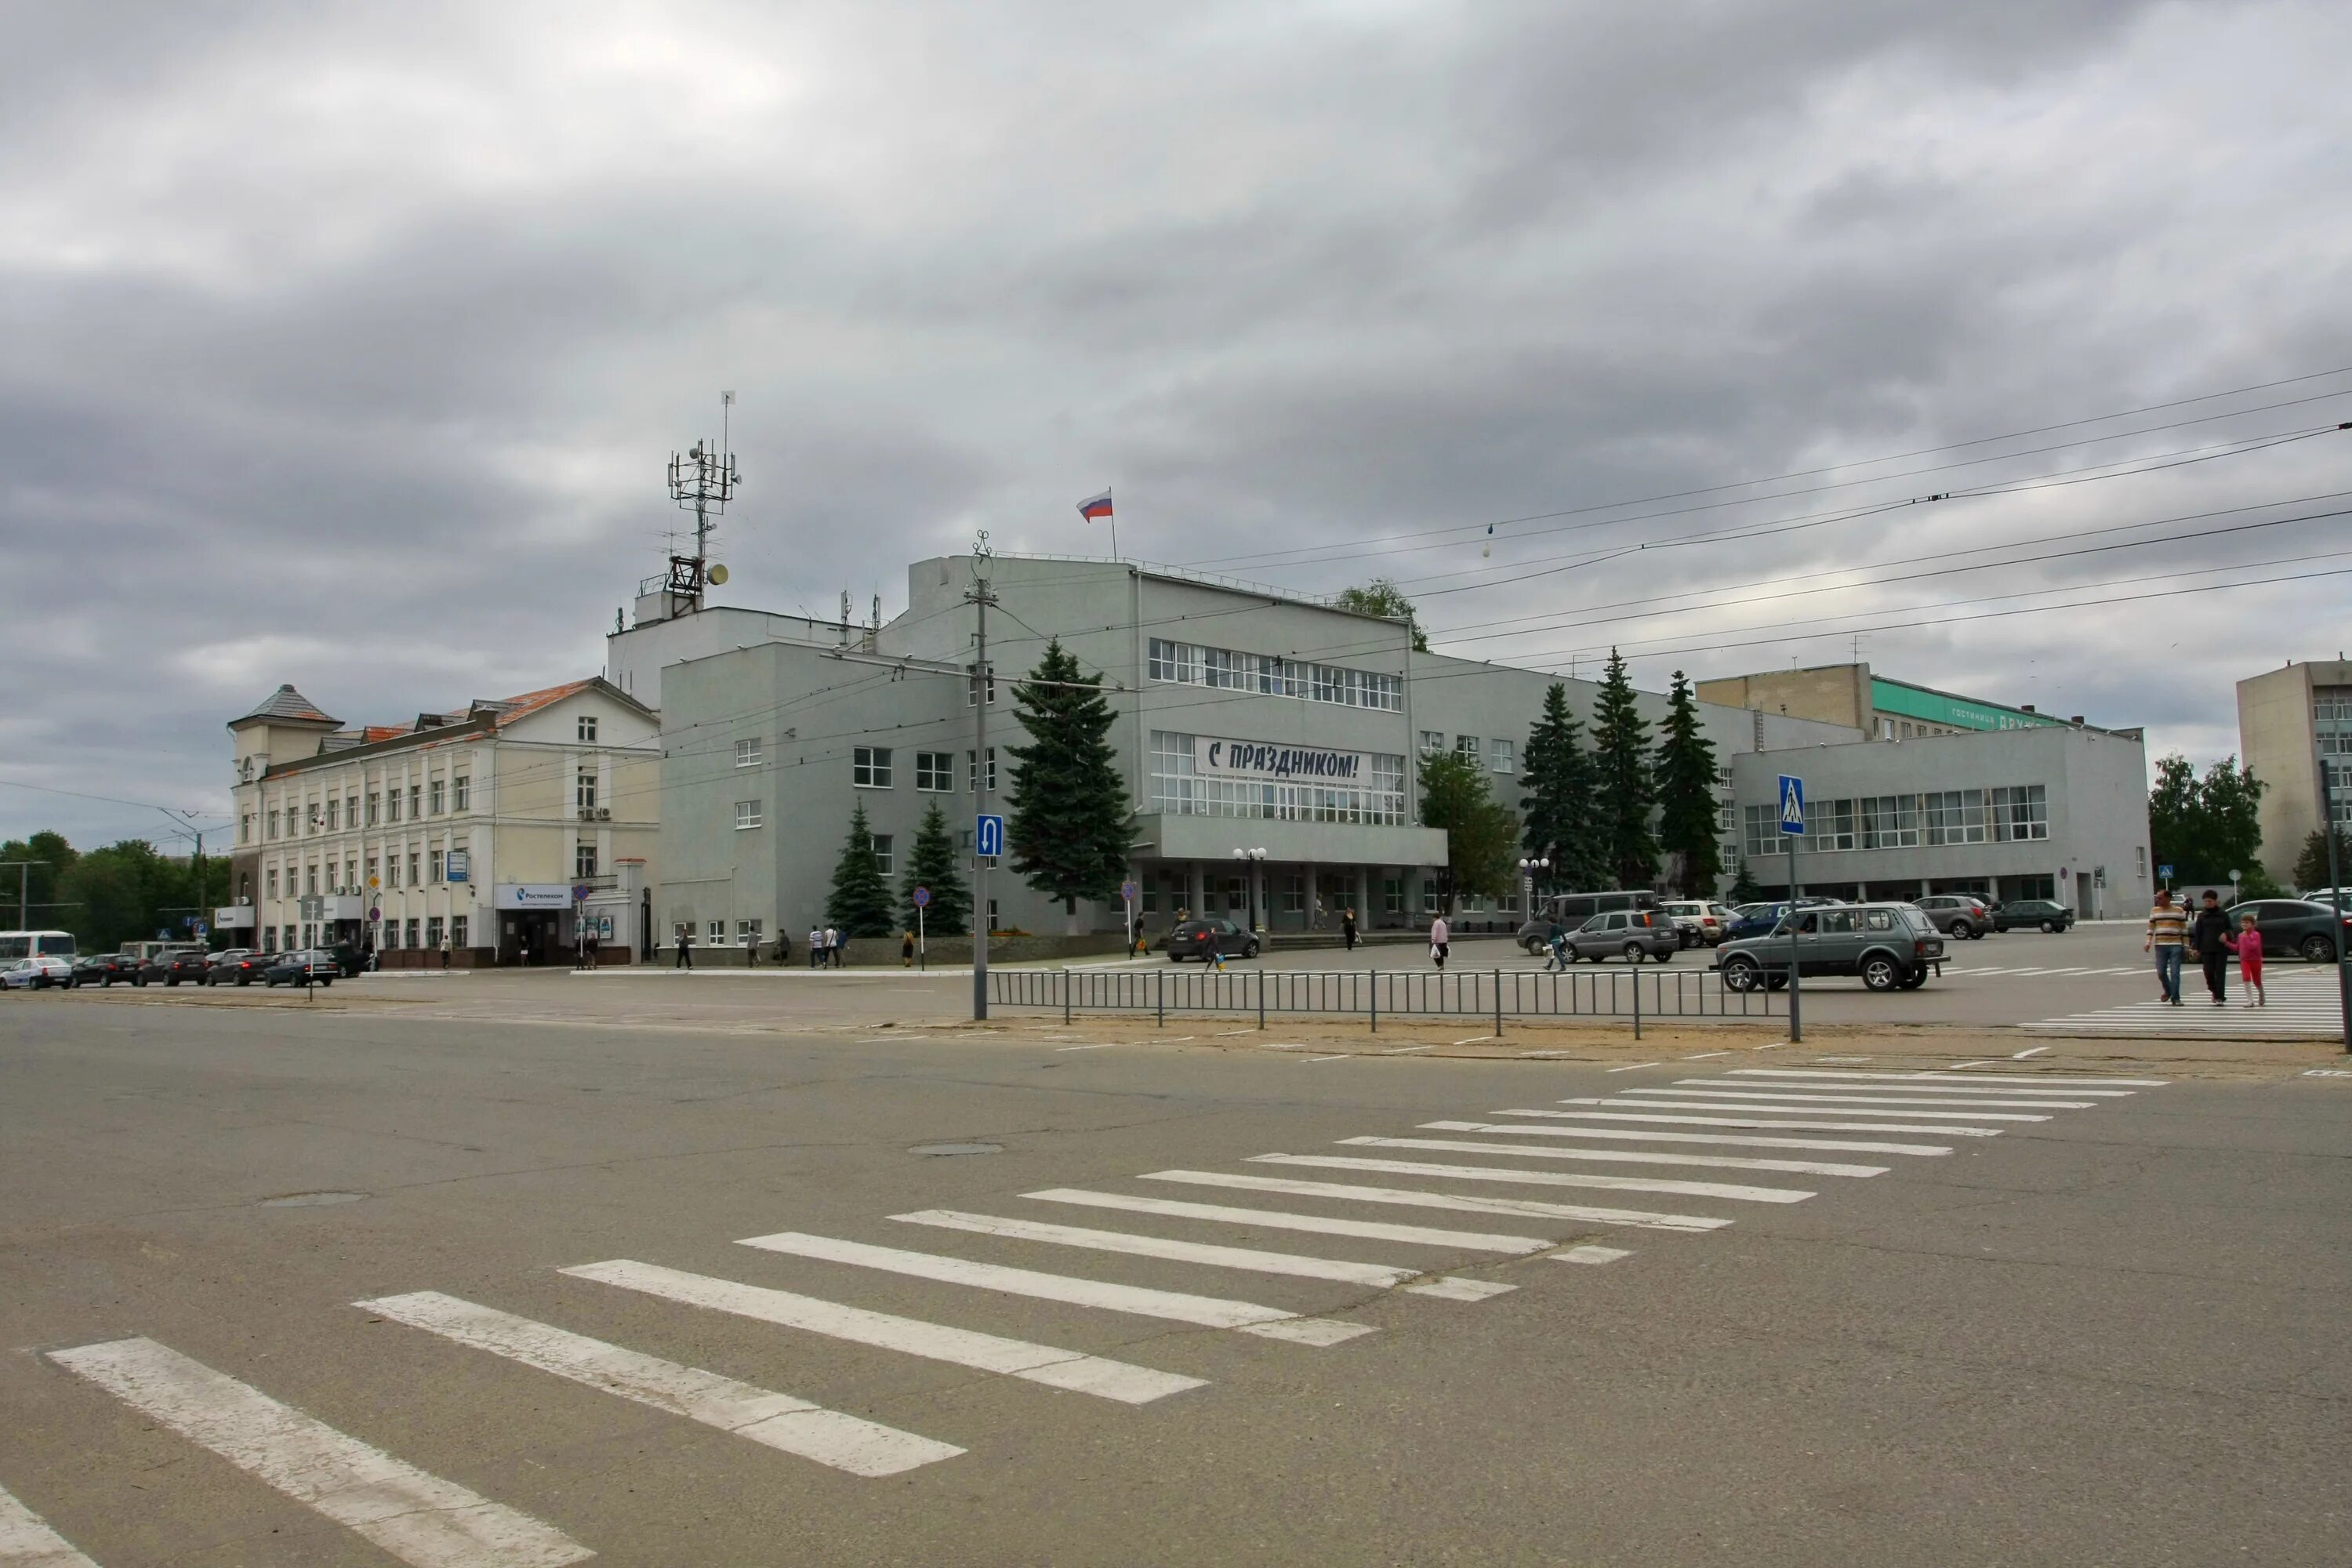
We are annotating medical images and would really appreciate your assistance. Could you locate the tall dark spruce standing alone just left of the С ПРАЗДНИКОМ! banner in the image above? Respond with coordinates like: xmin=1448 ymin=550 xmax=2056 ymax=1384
xmin=1004 ymin=637 xmax=1134 ymax=924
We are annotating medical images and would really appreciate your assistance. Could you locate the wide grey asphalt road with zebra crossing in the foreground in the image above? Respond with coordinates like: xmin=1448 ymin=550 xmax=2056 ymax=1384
xmin=0 ymin=1001 xmax=2352 ymax=1568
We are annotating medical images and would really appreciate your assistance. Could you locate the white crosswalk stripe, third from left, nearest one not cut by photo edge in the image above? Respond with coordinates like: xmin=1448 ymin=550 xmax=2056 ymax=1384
xmin=353 ymin=1290 xmax=964 ymax=1476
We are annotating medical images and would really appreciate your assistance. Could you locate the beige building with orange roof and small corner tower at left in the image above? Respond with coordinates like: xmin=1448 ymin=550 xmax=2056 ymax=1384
xmin=216 ymin=680 xmax=661 ymax=966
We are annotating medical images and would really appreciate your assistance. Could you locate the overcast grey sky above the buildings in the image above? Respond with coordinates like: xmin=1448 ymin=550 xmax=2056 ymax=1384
xmin=0 ymin=0 xmax=2352 ymax=844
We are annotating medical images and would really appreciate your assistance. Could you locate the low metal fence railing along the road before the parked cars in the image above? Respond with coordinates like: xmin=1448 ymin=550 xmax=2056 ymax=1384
xmin=988 ymin=966 xmax=1780 ymax=1036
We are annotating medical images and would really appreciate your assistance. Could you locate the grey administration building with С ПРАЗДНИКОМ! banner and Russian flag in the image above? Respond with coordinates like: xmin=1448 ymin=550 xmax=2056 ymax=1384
xmin=607 ymin=555 xmax=2147 ymax=945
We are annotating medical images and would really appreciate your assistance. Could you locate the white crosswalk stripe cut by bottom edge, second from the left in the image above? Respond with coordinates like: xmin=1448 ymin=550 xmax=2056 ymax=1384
xmin=49 ymin=1340 xmax=595 ymax=1568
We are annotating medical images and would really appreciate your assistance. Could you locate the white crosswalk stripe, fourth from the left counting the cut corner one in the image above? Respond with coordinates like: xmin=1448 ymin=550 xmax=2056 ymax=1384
xmin=557 ymin=1258 xmax=1207 ymax=1406
